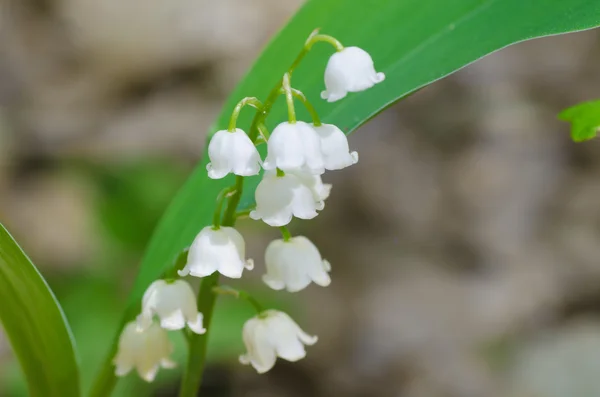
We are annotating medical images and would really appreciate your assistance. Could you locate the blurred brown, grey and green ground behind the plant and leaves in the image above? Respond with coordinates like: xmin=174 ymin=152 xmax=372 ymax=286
xmin=0 ymin=0 xmax=600 ymax=397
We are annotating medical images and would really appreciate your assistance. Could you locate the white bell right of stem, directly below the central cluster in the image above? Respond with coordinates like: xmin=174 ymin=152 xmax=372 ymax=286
xmin=263 ymin=236 xmax=331 ymax=292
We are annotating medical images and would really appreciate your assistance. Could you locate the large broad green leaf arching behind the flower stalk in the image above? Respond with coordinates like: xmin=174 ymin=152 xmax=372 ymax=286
xmin=96 ymin=0 xmax=600 ymax=390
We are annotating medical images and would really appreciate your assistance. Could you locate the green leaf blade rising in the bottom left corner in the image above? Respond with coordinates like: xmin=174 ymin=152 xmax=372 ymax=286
xmin=0 ymin=225 xmax=80 ymax=397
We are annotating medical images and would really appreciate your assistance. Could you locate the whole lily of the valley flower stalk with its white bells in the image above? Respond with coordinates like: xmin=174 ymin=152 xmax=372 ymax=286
xmin=113 ymin=32 xmax=385 ymax=397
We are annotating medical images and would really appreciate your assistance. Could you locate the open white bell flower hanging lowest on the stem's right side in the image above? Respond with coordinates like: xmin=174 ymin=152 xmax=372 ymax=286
xmin=240 ymin=310 xmax=317 ymax=374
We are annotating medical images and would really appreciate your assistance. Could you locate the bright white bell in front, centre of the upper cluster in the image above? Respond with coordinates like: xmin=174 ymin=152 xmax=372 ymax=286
xmin=263 ymin=121 xmax=325 ymax=175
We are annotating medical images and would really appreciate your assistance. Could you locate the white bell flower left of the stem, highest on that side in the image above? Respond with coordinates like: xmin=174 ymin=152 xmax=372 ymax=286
xmin=206 ymin=128 xmax=260 ymax=179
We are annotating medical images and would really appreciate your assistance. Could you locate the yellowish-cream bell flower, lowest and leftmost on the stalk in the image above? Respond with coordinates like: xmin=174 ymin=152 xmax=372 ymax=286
xmin=113 ymin=321 xmax=176 ymax=382
